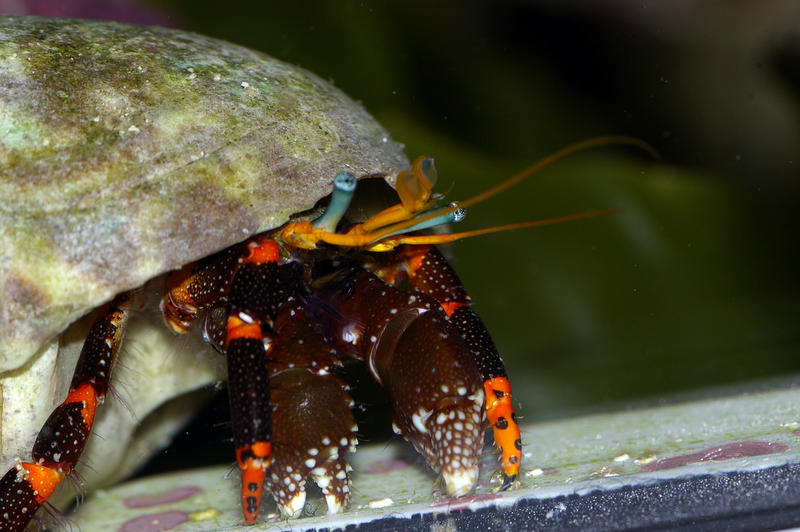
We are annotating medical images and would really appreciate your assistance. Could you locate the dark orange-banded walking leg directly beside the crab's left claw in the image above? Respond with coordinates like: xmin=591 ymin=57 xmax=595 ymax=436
xmin=161 ymin=235 xmax=281 ymax=523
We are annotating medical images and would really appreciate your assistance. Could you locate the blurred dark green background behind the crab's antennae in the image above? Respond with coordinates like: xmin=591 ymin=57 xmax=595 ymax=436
xmin=7 ymin=0 xmax=800 ymax=422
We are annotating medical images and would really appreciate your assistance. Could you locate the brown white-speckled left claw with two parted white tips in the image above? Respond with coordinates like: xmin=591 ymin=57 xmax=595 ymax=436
xmin=267 ymin=301 xmax=358 ymax=517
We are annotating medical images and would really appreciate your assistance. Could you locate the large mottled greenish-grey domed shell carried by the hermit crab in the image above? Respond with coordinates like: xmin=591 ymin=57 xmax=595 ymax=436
xmin=0 ymin=17 xmax=408 ymax=504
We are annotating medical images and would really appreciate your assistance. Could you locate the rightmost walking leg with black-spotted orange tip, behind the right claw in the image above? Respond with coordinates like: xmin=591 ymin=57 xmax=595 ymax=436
xmin=382 ymin=245 xmax=522 ymax=488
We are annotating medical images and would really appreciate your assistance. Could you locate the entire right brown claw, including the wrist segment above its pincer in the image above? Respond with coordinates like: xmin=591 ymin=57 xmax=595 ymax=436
xmin=316 ymin=269 xmax=485 ymax=496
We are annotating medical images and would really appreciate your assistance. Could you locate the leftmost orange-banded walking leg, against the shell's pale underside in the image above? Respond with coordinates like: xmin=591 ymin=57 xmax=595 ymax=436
xmin=0 ymin=294 xmax=130 ymax=530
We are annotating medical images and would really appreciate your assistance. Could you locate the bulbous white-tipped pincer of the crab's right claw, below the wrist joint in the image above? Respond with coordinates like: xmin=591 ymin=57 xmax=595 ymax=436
xmin=372 ymin=310 xmax=484 ymax=496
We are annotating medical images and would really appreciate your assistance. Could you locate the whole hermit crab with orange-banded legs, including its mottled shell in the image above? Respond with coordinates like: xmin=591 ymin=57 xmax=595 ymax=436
xmin=0 ymin=17 xmax=536 ymax=530
